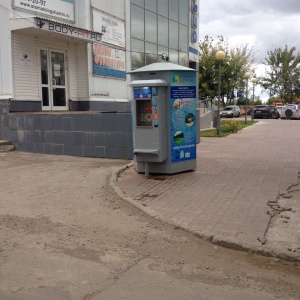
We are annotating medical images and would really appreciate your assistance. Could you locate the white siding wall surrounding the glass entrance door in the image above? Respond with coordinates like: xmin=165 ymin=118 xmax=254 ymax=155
xmin=12 ymin=31 xmax=88 ymax=101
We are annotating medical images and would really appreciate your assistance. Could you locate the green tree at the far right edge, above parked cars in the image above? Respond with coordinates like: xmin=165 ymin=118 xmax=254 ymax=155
xmin=259 ymin=46 xmax=300 ymax=103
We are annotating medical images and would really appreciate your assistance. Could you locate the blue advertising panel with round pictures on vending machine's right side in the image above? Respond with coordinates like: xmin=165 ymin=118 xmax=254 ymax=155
xmin=170 ymin=71 xmax=196 ymax=162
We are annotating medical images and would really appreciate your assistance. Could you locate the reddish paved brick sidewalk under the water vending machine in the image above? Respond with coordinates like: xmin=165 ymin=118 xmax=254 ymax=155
xmin=116 ymin=120 xmax=300 ymax=259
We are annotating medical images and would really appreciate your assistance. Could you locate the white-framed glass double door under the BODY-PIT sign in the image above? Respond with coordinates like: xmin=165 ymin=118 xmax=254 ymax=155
xmin=40 ymin=49 xmax=68 ymax=110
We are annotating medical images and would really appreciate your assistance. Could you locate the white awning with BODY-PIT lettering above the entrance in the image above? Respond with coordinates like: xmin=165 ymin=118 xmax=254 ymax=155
xmin=11 ymin=17 xmax=102 ymax=43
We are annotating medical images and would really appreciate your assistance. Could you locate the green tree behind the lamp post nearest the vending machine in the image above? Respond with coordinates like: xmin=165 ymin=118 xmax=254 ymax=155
xmin=199 ymin=36 xmax=254 ymax=106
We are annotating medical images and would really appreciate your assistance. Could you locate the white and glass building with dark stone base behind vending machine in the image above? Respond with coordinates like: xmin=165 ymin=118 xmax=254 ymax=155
xmin=0 ymin=0 xmax=199 ymax=159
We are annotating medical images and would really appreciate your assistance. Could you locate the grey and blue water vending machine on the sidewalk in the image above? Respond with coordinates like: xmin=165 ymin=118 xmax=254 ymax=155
xmin=131 ymin=62 xmax=197 ymax=175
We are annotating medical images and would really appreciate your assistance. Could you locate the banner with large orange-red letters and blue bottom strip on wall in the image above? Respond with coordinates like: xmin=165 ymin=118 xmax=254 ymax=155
xmin=93 ymin=44 xmax=126 ymax=78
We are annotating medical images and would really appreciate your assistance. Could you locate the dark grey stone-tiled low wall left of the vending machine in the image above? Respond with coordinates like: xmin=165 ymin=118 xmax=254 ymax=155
xmin=0 ymin=105 xmax=133 ymax=159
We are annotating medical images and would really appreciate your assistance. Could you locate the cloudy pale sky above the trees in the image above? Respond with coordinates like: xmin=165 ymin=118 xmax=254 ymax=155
xmin=199 ymin=0 xmax=300 ymax=101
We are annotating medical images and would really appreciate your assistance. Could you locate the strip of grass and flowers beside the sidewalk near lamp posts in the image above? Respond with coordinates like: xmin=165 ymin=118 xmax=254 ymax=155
xmin=200 ymin=119 xmax=257 ymax=137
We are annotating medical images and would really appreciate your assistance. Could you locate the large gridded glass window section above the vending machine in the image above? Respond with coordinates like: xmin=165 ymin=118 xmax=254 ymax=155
xmin=130 ymin=0 xmax=190 ymax=69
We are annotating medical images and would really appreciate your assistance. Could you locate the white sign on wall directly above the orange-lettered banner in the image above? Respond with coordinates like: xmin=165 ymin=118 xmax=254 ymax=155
xmin=93 ymin=10 xmax=125 ymax=48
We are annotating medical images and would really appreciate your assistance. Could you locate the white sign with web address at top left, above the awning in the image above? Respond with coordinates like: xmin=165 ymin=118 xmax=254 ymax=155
xmin=13 ymin=0 xmax=75 ymax=22
